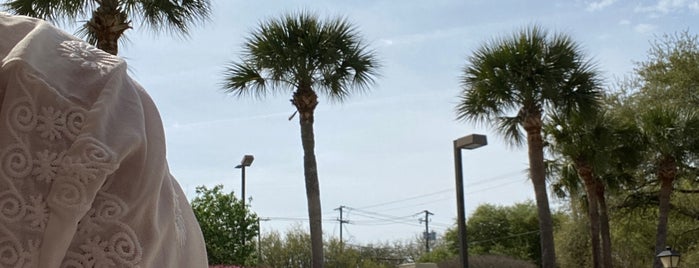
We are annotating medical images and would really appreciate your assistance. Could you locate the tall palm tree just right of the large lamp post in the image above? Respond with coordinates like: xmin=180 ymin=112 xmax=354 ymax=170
xmin=457 ymin=26 xmax=600 ymax=268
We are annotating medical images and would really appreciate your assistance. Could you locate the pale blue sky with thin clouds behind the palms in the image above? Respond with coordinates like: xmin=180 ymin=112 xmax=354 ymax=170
xmin=43 ymin=0 xmax=699 ymax=245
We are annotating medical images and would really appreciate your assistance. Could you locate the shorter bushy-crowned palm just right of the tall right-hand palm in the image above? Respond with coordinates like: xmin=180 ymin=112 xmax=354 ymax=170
xmin=544 ymin=111 xmax=640 ymax=267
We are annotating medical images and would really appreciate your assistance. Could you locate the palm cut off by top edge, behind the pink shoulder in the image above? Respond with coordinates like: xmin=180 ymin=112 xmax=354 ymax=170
xmin=4 ymin=0 xmax=211 ymax=55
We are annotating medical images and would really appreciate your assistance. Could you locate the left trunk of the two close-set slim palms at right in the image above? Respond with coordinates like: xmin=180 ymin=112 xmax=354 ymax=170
xmin=575 ymin=161 xmax=604 ymax=268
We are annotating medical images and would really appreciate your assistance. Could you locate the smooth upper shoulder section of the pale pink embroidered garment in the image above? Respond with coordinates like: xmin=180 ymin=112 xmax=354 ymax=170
xmin=0 ymin=11 xmax=127 ymax=107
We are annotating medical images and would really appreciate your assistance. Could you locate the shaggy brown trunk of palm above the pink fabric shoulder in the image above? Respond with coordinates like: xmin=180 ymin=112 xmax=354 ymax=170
xmin=85 ymin=0 xmax=131 ymax=55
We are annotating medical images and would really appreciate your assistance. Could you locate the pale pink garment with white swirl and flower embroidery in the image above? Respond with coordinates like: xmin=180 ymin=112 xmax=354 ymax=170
xmin=0 ymin=13 xmax=208 ymax=268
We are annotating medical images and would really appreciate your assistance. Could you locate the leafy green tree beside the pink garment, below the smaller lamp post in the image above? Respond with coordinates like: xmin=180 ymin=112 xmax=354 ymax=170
xmin=192 ymin=185 xmax=259 ymax=265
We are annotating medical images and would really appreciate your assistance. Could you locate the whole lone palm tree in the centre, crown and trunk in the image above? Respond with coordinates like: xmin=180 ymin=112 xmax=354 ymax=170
xmin=224 ymin=12 xmax=379 ymax=267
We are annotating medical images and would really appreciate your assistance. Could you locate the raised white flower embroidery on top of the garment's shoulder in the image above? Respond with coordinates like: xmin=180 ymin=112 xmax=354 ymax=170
xmin=58 ymin=40 xmax=119 ymax=75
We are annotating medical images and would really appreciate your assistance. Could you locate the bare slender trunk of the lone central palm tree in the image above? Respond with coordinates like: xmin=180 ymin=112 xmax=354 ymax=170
xmin=292 ymin=87 xmax=324 ymax=268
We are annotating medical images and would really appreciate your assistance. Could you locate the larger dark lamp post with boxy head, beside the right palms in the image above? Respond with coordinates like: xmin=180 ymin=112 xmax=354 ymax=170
xmin=454 ymin=134 xmax=488 ymax=268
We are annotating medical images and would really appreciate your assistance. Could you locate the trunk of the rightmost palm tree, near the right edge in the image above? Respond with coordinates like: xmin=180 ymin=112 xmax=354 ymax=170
xmin=653 ymin=157 xmax=677 ymax=268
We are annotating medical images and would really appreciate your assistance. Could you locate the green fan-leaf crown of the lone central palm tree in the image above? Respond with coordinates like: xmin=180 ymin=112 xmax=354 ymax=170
xmin=224 ymin=12 xmax=379 ymax=100
